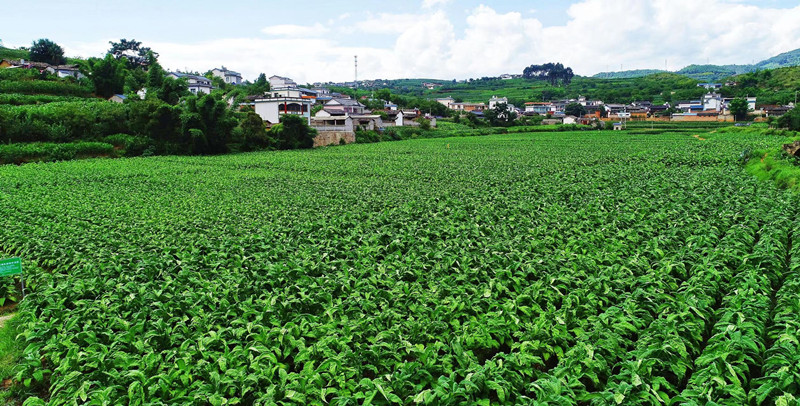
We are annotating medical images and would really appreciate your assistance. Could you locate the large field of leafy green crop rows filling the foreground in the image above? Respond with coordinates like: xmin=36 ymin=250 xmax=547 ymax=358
xmin=0 ymin=130 xmax=800 ymax=405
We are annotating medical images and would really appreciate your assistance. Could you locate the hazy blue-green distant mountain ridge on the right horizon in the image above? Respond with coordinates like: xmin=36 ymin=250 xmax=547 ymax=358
xmin=592 ymin=49 xmax=800 ymax=82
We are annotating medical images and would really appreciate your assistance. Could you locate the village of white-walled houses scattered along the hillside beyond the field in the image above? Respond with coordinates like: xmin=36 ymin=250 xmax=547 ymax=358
xmin=0 ymin=51 xmax=794 ymax=150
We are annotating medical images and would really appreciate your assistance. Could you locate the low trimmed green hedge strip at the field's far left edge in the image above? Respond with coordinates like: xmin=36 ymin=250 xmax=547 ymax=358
xmin=0 ymin=142 xmax=115 ymax=164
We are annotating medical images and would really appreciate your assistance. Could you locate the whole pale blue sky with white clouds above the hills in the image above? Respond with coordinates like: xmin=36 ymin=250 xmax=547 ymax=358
xmin=0 ymin=0 xmax=800 ymax=83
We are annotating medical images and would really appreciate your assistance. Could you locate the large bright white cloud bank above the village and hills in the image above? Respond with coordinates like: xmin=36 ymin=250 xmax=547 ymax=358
xmin=54 ymin=0 xmax=800 ymax=83
